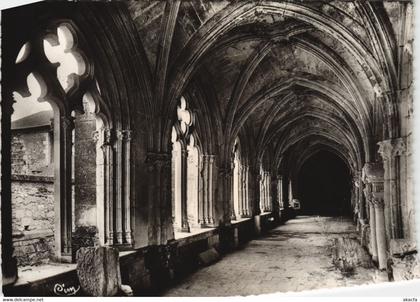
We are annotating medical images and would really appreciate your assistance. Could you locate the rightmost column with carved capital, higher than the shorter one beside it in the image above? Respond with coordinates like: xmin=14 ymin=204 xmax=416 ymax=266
xmin=378 ymin=138 xmax=406 ymax=239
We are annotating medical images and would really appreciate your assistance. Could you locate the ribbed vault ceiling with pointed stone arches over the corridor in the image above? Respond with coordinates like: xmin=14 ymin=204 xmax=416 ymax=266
xmin=129 ymin=1 xmax=398 ymax=176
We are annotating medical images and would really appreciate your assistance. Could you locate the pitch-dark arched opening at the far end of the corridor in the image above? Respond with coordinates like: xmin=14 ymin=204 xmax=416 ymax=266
xmin=298 ymin=151 xmax=351 ymax=216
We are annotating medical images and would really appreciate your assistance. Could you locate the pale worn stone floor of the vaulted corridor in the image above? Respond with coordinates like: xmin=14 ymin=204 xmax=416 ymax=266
xmin=164 ymin=216 xmax=375 ymax=296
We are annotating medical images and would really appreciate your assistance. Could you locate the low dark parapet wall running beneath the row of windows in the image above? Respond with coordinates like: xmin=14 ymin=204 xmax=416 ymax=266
xmin=3 ymin=214 xmax=275 ymax=297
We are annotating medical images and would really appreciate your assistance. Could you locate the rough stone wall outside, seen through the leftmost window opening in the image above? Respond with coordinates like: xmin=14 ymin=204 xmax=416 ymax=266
xmin=12 ymin=127 xmax=55 ymax=266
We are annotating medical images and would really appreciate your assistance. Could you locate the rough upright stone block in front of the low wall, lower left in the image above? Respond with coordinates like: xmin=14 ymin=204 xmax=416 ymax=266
xmin=76 ymin=246 xmax=121 ymax=297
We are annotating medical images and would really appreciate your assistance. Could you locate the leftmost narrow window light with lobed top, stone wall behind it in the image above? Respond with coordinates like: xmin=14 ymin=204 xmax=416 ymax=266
xmin=11 ymin=73 xmax=55 ymax=266
